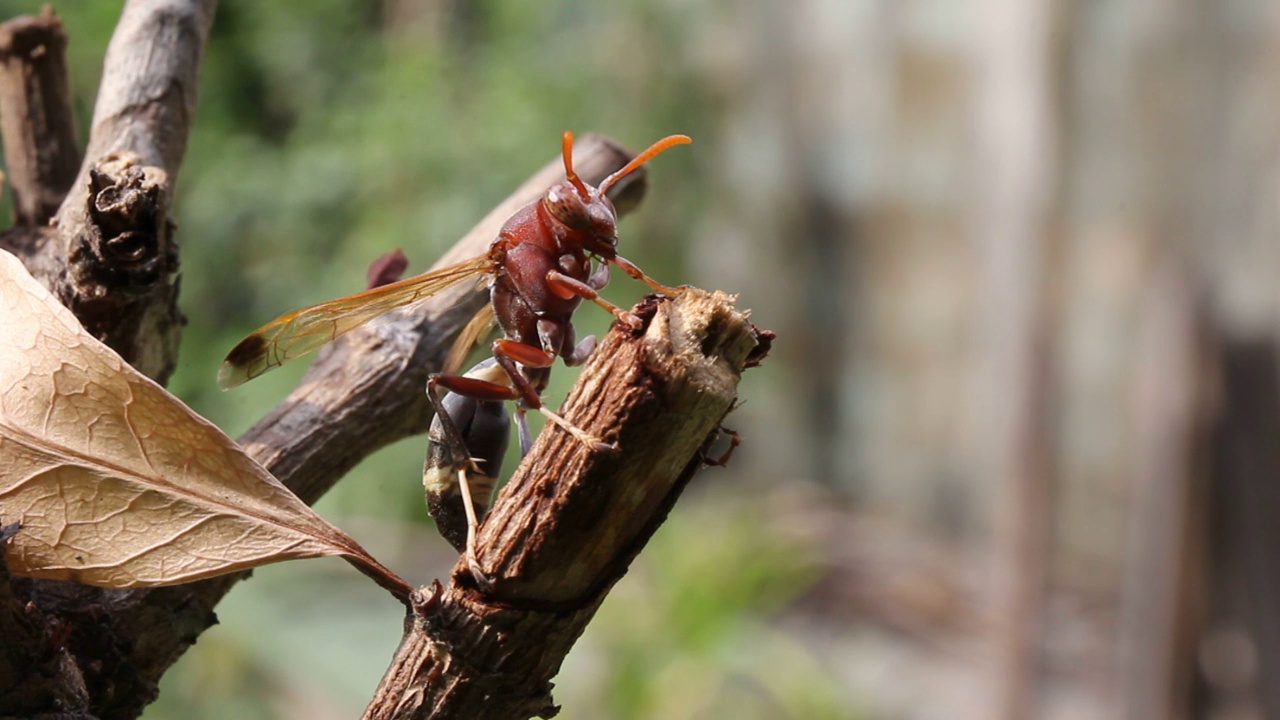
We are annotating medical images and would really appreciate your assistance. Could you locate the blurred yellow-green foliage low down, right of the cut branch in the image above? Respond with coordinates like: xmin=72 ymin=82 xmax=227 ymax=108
xmin=558 ymin=491 xmax=850 ymax=720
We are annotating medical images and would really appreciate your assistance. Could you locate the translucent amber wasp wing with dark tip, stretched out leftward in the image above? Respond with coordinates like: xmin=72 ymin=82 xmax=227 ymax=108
xmin=218 ymin=254 xmax=497 ymax=389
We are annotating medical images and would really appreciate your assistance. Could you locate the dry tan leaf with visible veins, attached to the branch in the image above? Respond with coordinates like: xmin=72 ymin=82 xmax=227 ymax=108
xmin=0 ymin=251 xmax=411 ymax=600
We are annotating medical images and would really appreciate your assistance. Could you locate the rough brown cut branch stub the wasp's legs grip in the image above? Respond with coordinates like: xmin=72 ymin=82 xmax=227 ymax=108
xmin=365 ymin=288 xmax=768 ymax=720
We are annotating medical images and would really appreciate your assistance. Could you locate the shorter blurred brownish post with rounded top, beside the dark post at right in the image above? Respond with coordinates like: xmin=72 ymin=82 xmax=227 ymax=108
xmin=1117 ymin=261 xmax=1210 ymax=720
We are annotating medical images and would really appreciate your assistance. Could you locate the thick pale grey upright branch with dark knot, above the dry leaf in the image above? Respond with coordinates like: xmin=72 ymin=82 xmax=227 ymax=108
xmin=4 ymin=0 xmax=216 ymax=382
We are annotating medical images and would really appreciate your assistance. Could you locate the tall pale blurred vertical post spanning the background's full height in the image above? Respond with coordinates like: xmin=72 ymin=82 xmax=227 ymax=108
xmin=974 ymin=0 xmax=1060 ymax=720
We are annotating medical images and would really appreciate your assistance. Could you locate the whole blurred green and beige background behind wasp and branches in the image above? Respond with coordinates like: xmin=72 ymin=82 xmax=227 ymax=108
xmin=0 ymin=0 xmax=1280 ymax=720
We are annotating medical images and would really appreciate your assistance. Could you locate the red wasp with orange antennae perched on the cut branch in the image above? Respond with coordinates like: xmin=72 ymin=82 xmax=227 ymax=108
xmin=218 ymin=131 xmax=690 ymax=582
